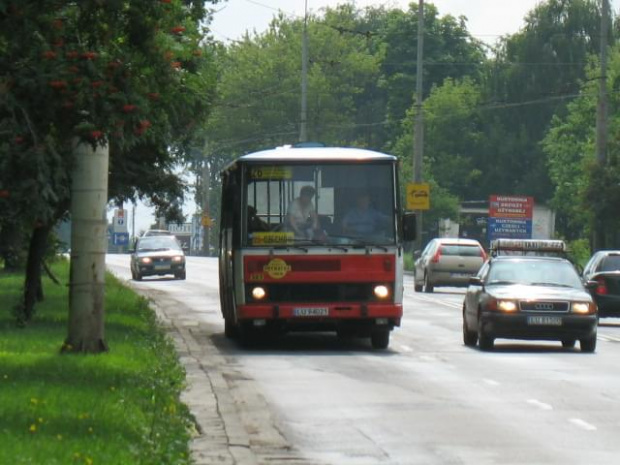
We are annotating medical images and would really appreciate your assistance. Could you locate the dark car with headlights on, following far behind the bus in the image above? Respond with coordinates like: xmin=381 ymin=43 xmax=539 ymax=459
xmin=131 ymin=236 xmax=185 ymax=281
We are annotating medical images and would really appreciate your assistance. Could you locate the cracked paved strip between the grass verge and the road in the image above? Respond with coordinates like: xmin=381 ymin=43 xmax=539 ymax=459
xmin=135 ymin=289 xmax=310 ymax=465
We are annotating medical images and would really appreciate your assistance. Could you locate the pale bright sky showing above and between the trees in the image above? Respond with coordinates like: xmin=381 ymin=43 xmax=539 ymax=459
xmin=123 ymin=0 xmax=620 ymax=233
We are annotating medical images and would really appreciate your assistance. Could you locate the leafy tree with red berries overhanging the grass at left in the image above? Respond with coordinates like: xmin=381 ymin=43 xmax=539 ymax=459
xmin=0 ymin=0 xmax=215 ymax=351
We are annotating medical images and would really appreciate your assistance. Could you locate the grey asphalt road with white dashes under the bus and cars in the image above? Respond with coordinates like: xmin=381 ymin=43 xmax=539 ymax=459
xmin=107 ymin=255 xmax=620 ymax=465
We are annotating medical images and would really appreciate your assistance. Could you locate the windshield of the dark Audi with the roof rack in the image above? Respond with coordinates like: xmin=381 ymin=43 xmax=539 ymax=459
xmin=486 ymin=260 xmax=583 ymax=289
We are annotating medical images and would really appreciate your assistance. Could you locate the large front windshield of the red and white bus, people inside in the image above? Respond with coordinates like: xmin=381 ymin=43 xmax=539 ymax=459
xmin=243 ymin=163 xmax=397 ymax=247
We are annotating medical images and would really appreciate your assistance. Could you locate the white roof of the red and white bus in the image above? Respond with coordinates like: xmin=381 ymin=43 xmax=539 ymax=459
xmin=224 ymin=145 xmax=397 ymax=171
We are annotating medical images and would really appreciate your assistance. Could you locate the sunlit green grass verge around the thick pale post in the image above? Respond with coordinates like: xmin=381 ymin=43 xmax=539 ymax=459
xmin=0 ymin=261 xmax=192 ymax=465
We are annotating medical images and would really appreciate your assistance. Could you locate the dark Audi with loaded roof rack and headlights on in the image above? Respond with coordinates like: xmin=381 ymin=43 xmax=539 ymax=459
xmin=463 ymin=241 xmax=598 ymax=352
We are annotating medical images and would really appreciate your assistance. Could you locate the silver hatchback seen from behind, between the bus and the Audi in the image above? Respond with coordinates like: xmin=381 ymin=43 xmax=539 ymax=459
xmin=413 ymin=238 xmax=487 ymax=292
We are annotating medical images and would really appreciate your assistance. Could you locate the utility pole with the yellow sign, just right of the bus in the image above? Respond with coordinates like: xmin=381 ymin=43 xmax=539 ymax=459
xmin=413 ymin=0 xmax=424 ymax=249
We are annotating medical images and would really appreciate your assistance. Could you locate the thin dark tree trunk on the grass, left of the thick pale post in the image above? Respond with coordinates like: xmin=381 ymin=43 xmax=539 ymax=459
xmin=19 ymin=226 xmax=51 ymax=323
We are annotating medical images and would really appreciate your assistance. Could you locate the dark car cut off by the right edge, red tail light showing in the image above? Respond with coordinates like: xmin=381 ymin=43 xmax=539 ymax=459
xmin=582 ymin=250 xmax=620 ymax=317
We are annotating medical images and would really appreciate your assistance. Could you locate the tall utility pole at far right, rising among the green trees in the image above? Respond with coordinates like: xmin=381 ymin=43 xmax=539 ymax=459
xmin=592 ymin=0 xmax=609 ymax=250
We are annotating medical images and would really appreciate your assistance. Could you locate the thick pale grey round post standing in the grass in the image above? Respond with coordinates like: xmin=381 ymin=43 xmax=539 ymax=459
xmin=62 ymin=143 xmax=109 ymax=353
